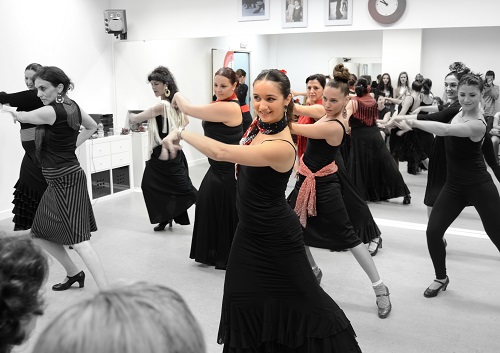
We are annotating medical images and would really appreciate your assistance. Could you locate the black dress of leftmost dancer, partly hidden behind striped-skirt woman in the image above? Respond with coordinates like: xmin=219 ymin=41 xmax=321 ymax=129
xmin=0 ymin=90 xmax=47 ymax=230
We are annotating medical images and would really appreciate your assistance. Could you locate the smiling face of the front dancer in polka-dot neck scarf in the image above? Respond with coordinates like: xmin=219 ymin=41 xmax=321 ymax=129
xmin=253 ymin=80 xmax=292 ymax=123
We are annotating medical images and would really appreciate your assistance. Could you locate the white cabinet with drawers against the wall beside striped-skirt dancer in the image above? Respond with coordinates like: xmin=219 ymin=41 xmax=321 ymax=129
xmin=76 ymin=135 xmax=134 ymax=199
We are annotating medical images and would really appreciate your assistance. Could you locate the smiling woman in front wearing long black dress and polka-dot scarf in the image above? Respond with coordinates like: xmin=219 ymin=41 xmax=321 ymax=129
xmin=164 ymin=70 xmax=360 ymax=353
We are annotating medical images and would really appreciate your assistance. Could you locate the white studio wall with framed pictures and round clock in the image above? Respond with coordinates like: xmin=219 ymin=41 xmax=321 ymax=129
xmin=0 ymin=0 xmax=500 ymax=218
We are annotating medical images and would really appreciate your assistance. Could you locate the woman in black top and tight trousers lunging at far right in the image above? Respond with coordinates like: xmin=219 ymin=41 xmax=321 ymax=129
xmin=396 ymin=73 xmax=500 ymax=298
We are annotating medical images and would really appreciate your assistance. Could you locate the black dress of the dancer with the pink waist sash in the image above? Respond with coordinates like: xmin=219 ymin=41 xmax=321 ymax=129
xmin=288 ymin=120 xmax=380 ymax=245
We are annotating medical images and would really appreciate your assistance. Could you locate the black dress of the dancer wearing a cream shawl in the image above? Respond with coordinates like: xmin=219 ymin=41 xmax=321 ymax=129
xmin=141 ymin=115 xmax=197 ymax=225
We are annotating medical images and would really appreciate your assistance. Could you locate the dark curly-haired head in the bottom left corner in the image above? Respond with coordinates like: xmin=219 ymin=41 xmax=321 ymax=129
xmin=0 ymin=232 xmax=49 ymax=353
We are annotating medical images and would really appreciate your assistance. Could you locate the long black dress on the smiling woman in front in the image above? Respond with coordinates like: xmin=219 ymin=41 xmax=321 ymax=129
xmin=218 ymin=142 xmax=361 ymax=353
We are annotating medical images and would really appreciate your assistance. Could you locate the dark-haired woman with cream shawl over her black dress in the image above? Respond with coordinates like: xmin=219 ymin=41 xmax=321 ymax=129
xmin=129 ymin=66 xmax=197 ymax=231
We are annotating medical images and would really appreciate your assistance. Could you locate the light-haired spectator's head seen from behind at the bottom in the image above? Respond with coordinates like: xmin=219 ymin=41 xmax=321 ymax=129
xmin=33 ymin=282 xmax=205 ymax=353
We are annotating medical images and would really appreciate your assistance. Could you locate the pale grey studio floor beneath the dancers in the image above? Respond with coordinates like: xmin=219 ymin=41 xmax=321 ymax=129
xmin=4 ymin=160 xmax=500 ymax=353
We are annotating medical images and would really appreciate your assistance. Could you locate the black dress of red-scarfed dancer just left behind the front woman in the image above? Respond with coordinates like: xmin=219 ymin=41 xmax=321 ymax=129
xmin=190 ymin=117 xmax=243 ymax=269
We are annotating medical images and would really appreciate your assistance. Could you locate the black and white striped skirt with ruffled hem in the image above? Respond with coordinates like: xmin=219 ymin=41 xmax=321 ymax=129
xmin=31 ymin=165 xmax=97 ymax=245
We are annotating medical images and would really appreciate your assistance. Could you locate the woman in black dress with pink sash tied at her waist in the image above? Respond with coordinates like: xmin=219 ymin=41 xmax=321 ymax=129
xmin=291 ymin=64 xmax=391 ymax=318
